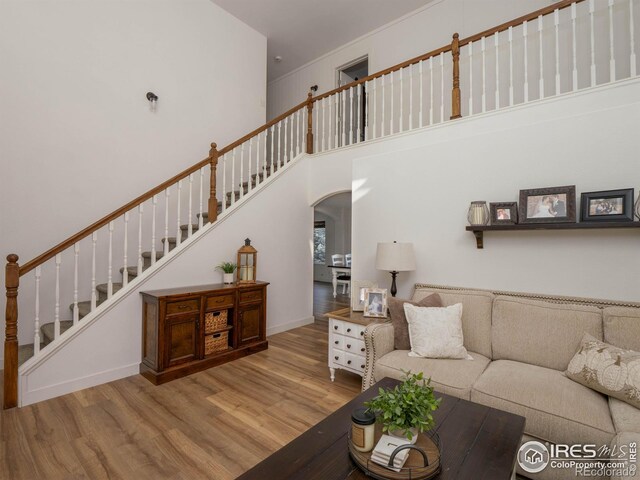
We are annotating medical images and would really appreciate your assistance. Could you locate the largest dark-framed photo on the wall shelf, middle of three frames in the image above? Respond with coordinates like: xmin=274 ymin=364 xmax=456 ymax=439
xmin=518 ymin=185 xmax=576 ymax=223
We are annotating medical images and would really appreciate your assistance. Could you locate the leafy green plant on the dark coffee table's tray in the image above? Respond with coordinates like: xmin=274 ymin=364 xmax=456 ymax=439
xmin=365 ymin=372 xmax=442 ymax=443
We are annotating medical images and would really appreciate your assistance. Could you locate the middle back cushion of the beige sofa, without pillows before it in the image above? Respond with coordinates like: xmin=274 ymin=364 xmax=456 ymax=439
xmin=492 ymin=296 xmax=602 ymax=370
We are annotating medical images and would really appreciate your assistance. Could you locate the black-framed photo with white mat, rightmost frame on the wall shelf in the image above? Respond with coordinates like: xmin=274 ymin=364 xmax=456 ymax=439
xmin=580 ymin=188 xmax=634 ymax=222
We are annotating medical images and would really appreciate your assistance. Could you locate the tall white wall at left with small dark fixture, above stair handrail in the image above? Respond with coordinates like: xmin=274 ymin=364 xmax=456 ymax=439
xmin=0 ymin=0 xmax=266 ymax=368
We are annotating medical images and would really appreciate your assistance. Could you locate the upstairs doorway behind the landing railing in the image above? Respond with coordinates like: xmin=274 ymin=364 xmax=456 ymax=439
xmin=336 ymin=56 xmax=369 ymax=146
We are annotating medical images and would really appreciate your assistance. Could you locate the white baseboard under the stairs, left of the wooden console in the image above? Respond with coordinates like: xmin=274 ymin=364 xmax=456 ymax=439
xmin=19 ymin=362 xmax=140 ymax=407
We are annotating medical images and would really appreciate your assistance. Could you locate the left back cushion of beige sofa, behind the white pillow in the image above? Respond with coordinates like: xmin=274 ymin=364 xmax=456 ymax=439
xmin=412 ymin=287 xmax=494 ymax=358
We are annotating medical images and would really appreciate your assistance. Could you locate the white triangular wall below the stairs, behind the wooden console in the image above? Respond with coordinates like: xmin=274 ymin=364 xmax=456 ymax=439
xmin=21 ymin=158 xmax=313 ymax=404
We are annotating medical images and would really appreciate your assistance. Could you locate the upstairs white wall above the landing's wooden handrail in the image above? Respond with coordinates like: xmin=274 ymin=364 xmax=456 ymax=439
xmin=267 ymin=0 xmax=550 ymax=118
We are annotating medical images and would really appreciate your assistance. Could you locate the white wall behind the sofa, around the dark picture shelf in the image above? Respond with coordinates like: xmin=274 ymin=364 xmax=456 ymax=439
xmin=344 ymin=79 xmax=640 ymax=301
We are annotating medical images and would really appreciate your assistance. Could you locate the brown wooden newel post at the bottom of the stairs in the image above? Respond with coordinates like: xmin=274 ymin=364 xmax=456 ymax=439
xmin=3 ymin=253 xmax=20 ymax=409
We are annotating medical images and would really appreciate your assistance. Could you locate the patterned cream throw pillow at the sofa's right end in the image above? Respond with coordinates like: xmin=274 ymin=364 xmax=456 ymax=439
xmin=565 ymin=333 xmax=640 ymax=408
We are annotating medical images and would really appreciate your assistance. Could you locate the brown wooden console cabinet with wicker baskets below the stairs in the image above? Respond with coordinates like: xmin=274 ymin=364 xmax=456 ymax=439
xmin=140 ymin=282 xmax=268 ymax=385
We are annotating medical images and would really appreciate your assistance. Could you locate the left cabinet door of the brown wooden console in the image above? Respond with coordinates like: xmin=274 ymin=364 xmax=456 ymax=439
xmin=164 ymin=315 xmax=199 ymax=368
